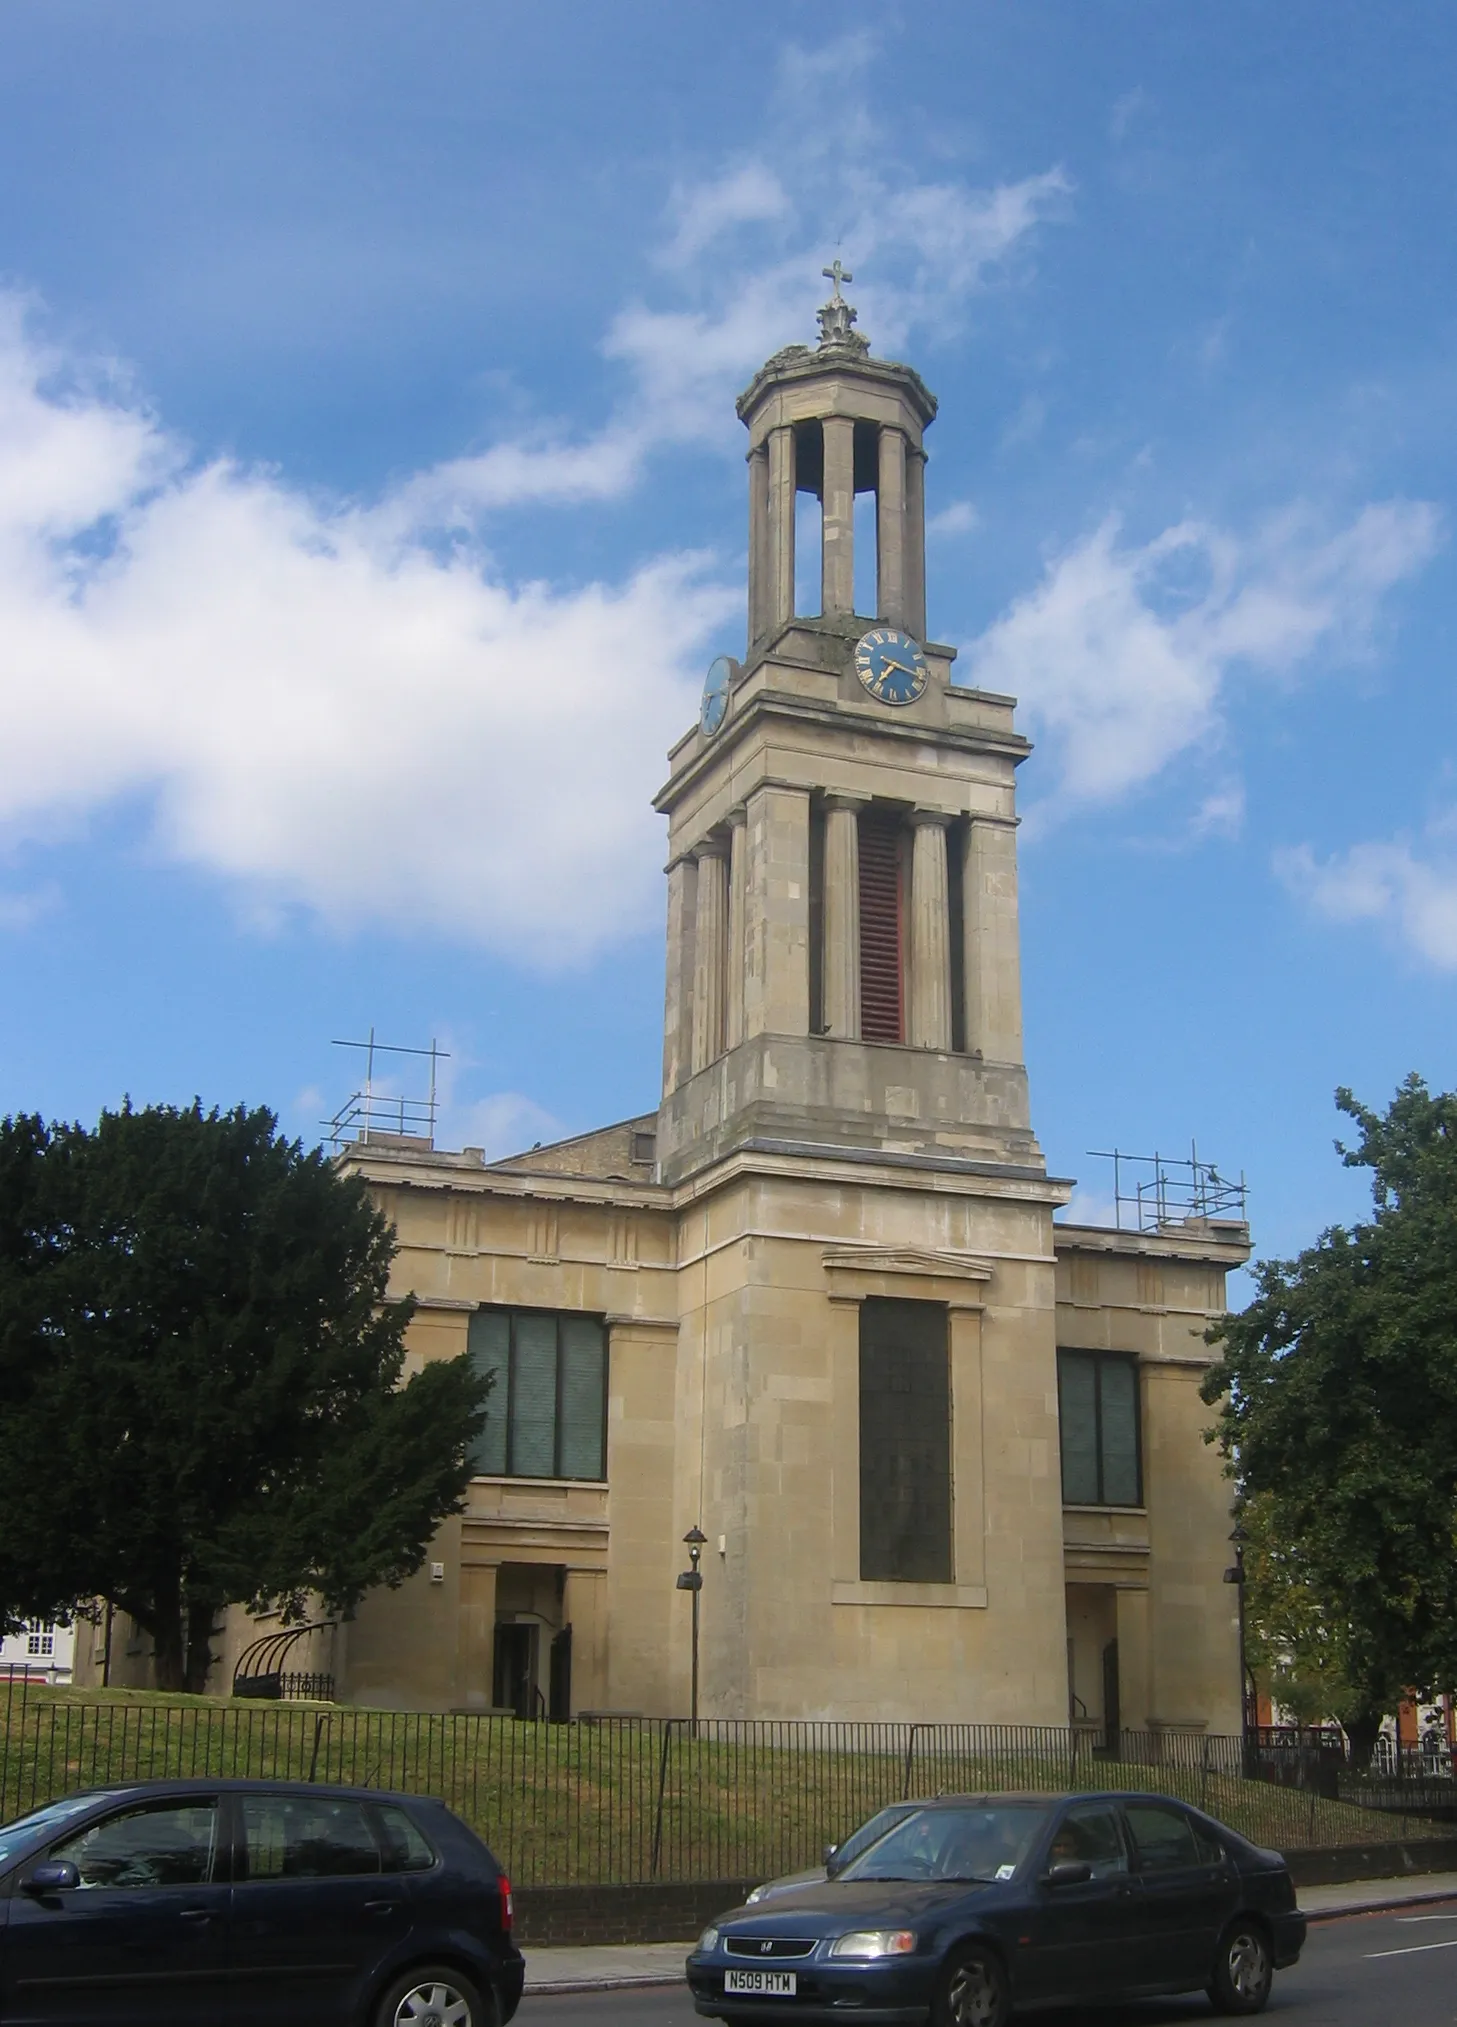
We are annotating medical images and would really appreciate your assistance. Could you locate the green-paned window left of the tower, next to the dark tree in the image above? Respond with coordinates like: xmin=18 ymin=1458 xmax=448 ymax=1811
xmin=470 ymin=1309 xmax=608 ymax=1478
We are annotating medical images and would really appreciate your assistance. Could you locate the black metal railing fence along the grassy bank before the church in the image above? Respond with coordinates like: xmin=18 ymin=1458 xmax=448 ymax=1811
xmin=0 ymin=1680 xmax=1441 ymax=1885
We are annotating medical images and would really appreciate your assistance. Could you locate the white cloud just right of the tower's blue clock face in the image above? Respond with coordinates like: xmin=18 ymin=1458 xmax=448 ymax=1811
xmin=969 ymin=501 xmax=1441 ymax=821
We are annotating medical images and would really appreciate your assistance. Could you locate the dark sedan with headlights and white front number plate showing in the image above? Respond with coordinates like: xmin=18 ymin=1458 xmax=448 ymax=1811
xmin=687 ymin=1794 xmax=1305 ymax=2027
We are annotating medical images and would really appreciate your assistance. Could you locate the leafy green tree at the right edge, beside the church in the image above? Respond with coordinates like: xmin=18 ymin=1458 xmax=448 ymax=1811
xmin=1204 ymin=1076 xmax=1457 ymax=1763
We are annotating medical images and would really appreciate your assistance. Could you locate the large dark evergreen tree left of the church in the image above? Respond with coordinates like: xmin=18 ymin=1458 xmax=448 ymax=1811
xmin=0 ymin=1103 xmax=488 ymax=1691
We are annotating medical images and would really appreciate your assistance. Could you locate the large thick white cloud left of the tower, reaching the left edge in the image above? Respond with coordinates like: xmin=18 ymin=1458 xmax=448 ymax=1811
xmin=0 ymin=314 xmax=736 ymax=963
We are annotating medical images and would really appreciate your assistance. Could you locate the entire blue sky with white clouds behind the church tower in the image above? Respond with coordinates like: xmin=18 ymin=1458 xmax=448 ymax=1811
xmin=0 ymin=0 xmax=1457 ymax=1253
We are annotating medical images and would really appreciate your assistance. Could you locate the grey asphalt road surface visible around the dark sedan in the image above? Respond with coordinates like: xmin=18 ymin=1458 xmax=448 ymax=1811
xmin=517 ymin=1899 xmax=1457 ymax=2027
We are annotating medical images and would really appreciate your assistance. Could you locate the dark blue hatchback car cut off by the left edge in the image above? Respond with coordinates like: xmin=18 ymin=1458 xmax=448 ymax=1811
xmin=0 ymin=1780 xmax=523 ymax=2027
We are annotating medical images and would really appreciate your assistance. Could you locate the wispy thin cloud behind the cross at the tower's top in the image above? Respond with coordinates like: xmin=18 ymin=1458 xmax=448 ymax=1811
xmin=421 ymin=34 xmax=1072 ymax=525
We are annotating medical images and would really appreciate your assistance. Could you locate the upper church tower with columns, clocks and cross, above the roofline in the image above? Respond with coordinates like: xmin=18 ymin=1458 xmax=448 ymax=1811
xmin=657 ymin=261 xmax=1042 ymax=1182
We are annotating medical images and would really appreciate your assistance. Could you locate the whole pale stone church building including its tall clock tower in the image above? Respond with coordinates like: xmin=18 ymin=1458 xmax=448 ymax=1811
xmin=81 ymin=277 xmax=1248 ymax=1731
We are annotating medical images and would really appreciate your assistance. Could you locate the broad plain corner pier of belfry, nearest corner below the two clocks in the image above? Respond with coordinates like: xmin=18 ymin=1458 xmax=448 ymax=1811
xmin=744 ymin=782 xmax=809 ymax=1036
